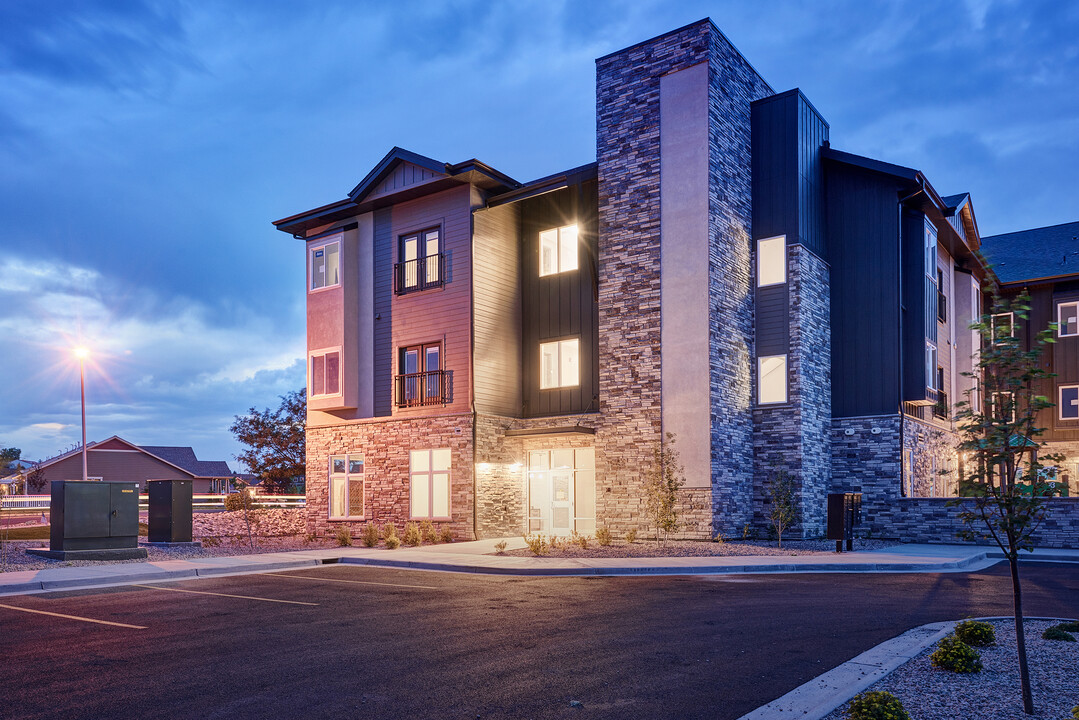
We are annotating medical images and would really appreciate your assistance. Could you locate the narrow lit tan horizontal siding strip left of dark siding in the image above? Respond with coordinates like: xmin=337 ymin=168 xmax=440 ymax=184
xmin=473 ymin=190 xmax=521 ymax=417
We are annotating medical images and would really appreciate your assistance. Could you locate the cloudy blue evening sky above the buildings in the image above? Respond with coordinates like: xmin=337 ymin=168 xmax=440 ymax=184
xmin=0 ymin=0 xmax=1079 ymax=467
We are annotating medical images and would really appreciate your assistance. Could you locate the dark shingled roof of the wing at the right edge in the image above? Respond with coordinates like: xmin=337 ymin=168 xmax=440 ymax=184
xmin=982 ymin=222 xmax=1079 ymax=284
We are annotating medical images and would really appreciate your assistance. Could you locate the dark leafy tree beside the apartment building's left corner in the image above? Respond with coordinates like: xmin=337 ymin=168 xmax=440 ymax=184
xmin=229 ymin=388 xmax=308 ymax=494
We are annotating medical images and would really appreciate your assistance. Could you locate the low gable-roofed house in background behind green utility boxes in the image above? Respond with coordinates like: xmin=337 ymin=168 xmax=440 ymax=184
xmin=33 ymin=435 xmax=233 ymax=494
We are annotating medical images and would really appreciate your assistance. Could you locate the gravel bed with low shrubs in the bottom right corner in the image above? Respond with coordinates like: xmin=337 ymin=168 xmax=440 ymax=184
xmin=824 ymin=620 xmax=1079 ymax=720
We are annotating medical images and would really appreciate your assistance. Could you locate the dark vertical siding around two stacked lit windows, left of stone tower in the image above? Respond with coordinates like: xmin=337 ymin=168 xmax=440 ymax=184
xmin=520 ymin=181 xmax=599 ymax=417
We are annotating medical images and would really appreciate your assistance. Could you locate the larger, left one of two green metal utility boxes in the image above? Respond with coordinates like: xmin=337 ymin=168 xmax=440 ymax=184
xmin=49 ymin=480 xmax=138 ymax=552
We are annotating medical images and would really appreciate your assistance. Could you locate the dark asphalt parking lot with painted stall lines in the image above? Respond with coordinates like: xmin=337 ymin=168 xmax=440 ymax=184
xmin=0 ymin=563 xmax=1079 ymax=720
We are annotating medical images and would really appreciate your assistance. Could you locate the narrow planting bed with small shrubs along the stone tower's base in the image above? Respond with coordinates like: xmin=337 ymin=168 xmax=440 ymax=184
xmin=503 ymin=539 xmax=896 ymax=557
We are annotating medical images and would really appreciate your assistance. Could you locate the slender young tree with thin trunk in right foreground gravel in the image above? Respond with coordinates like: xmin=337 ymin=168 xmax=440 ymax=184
xmin=951 ymin=290 xmax=1063 ymax=715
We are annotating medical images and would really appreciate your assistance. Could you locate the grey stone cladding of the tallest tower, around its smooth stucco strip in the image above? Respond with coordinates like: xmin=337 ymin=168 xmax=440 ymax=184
xmin=596 ymin=21 xmax=771 ymax=535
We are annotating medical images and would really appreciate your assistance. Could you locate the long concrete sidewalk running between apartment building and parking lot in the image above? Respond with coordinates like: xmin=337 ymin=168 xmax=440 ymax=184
xmin=0 ymin=538 xmax=1079 ymax=596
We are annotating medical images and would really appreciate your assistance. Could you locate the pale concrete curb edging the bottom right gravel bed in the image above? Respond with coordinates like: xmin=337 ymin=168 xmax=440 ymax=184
xmin=738 ymin=615 xmax=1068 ymax=720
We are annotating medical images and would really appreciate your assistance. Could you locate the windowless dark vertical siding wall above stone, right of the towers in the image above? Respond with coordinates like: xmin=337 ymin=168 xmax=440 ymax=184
xmin=825 ymin=163 xmax=900 ymax=418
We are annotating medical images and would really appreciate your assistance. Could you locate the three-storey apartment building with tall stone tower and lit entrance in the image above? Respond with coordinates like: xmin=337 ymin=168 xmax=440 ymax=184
xmin=274 ymin=19 xmax=1079 ymax=543
